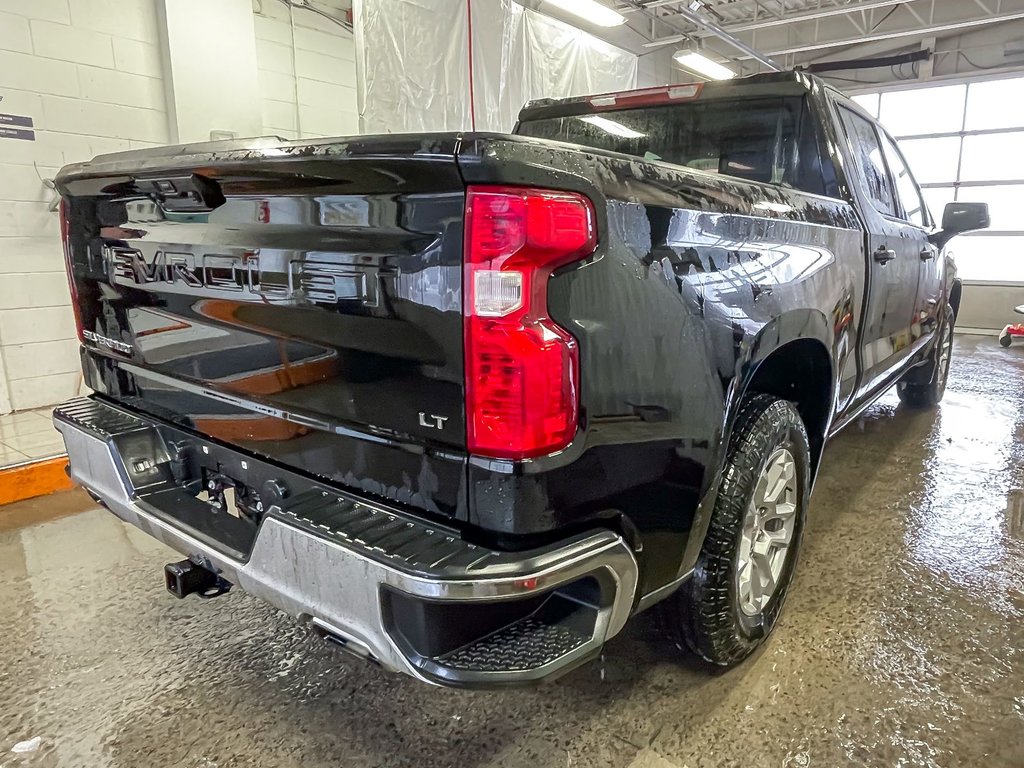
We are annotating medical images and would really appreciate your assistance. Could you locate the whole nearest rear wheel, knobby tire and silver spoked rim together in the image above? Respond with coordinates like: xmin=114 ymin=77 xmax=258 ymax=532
xmin=662 ymin=394 xmax=810 ymax=667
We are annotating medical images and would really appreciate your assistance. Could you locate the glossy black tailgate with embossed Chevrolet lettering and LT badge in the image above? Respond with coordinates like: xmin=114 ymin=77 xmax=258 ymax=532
xmin=57 ymin=134 xmax=466 ymax=517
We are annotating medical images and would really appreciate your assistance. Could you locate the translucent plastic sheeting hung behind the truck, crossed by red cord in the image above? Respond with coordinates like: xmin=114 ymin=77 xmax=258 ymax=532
xmin=354 ymin=0 xmax=637 ymax=133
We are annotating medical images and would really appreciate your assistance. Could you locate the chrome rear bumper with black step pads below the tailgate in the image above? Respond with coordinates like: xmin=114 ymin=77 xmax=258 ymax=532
xmin=53 ymin=398 xmax=637 ymax=687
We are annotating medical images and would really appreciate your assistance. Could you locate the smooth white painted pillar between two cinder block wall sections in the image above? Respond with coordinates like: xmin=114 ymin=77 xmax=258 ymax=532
xmin=158 ymin=0 xmax=261 ymax=143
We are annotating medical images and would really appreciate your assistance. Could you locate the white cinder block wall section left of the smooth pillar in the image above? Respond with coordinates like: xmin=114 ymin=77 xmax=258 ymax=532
xmin=0 ymin=0 xmax=167 ymax=413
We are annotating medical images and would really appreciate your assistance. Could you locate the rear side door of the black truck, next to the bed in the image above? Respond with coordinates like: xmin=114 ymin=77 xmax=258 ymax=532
xmin=838 ymin=103 xmax=923 ymax=398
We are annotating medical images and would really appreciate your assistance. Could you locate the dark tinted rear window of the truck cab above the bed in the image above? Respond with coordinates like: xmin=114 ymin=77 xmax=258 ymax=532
xmin=516 ymin=96 xmax=839 ymax=197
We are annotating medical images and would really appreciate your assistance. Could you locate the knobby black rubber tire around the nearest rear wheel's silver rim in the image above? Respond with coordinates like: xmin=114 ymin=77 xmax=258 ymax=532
xmin=662 ymin=394 xmax=811 ymax=667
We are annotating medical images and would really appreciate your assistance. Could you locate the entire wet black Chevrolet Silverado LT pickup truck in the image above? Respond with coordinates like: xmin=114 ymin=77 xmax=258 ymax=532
xmin=54 ymin=73 xmax=987 ymax=687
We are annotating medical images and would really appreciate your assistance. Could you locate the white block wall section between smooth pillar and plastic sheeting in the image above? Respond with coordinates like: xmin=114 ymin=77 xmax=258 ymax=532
xmin=254 ymin=0 xmax=359 ymax=138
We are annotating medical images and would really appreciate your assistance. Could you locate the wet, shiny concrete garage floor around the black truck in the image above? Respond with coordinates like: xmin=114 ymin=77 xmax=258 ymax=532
xmin=0 ymin=337 xmax=1024 ymax=768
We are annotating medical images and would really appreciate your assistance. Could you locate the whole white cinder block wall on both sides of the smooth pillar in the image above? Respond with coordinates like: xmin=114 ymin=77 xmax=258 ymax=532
xmin=0 ymin=0 xmax=358 ymax=413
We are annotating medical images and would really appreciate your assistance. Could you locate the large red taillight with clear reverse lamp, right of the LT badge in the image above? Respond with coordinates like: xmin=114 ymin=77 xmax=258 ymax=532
xmin=465 ymin=186 xmax=597 ymax=459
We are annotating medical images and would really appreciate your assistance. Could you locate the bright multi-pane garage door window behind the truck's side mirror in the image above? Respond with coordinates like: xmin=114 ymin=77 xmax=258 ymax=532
xmin=854 ymin=77 xmax=1024 ymax=283
